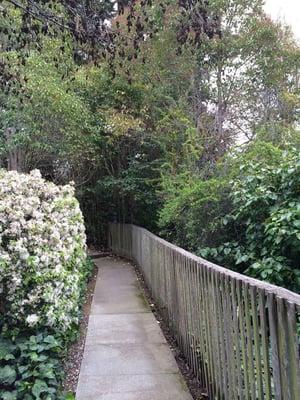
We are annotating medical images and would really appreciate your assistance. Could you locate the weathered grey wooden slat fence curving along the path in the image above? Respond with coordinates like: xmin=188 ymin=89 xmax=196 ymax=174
xmin=109 ymin=224 xmax=300 ymax=400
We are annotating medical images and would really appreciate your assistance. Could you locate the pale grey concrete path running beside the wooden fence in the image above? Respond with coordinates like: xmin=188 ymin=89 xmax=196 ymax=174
xmin=76 ymin=257 xmax=192 ymax=400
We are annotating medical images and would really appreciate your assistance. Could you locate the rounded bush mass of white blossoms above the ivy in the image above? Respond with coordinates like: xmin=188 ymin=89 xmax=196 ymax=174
xmin=0 ymin=170 xmax=86 ymax=331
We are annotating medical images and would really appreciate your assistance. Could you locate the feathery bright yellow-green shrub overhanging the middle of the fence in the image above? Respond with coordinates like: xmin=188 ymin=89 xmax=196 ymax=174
xmin=159 ymin=174 xmax=230 ymax=251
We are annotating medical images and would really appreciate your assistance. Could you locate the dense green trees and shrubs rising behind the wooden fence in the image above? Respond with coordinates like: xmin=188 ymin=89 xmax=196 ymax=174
xmin=0 ymin=0 xmax=300 ymax=318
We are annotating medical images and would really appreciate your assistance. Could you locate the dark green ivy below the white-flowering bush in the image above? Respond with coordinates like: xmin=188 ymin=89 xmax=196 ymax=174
xmin=0 ymin=333 xmax=63 ymax=400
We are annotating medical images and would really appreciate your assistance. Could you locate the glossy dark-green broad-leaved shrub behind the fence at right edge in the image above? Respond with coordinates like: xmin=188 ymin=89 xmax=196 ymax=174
xmin=199 ymin=150 xmax=300 ymax=291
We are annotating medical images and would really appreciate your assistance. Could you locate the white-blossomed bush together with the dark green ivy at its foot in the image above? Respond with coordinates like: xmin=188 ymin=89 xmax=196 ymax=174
xmin=0 ymin=171 xmax=92 ymax=400
